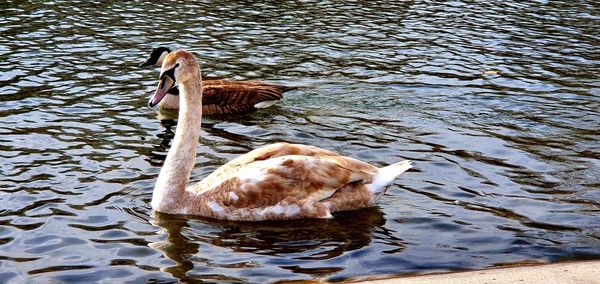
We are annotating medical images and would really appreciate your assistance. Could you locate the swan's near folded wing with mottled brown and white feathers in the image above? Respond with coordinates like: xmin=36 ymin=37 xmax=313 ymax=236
xmin=192 ymin=155 xmax=377 ymax=220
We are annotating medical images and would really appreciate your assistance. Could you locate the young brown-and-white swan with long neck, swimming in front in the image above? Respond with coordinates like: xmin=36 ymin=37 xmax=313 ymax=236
xmin=148 ymin=50 xmax=412 ymax=221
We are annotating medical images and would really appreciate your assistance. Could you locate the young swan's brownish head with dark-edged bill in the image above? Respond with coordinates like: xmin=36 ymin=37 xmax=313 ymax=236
xmin=148 ymin=50 xmax=201 ymax=107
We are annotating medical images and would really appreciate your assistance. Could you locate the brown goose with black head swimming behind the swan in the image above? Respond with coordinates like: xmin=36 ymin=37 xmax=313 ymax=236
xmin=140 ymin=46 xmax=297 ymax=114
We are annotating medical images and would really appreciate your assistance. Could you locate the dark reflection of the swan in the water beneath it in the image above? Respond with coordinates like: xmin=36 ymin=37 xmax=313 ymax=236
xmin=149 ymin=208 xmax=387 ymax=281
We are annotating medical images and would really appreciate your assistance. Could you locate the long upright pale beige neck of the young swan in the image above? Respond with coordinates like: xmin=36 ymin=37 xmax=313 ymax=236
xmin=152 ymin=71 xmax=202 ymax=213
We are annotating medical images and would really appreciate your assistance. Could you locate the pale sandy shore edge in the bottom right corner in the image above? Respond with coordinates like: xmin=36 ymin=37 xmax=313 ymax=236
xmin=351 ymin=261 xmax=600 ymax=284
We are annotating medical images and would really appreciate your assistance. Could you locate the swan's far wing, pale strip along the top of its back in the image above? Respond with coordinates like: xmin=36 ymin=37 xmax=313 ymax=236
xmin=194 ymin=142 xmax=340 ymax=191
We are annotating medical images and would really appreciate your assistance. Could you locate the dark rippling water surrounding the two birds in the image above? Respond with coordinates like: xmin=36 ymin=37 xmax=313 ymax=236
xmin=0 ymin=0 xmax=600 ymax=283
